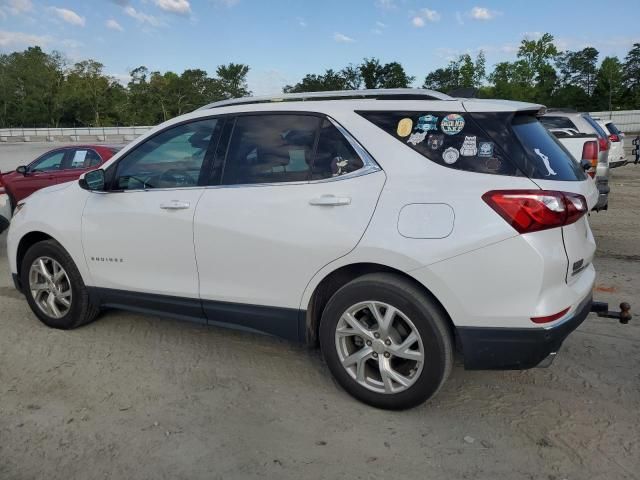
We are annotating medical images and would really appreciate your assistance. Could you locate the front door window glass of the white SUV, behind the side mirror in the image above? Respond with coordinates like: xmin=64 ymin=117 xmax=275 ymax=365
xmin=113 ymin=119 xmax=218 ymax=190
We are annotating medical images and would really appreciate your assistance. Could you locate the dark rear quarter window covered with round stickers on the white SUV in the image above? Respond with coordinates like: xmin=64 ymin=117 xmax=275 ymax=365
xmin=358 ymin=111 xmax=519 ymax=176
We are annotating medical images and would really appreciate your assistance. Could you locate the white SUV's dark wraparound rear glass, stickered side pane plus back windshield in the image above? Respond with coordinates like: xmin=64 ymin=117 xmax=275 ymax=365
xmin=357 ymin=111 xmax=586 ymax=181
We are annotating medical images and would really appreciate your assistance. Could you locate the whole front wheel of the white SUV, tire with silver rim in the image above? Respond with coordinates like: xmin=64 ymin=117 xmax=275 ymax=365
xmin=20 ymin=240 xmax=100 ymax=330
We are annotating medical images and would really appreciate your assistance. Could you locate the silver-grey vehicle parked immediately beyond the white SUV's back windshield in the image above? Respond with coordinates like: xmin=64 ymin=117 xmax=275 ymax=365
xmin=540 ymin=113 xmax=611 ymax=210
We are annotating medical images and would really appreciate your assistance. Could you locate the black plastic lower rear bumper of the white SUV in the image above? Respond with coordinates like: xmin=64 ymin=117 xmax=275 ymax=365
xmin=457 ymin=295 xmax=592 ymax=370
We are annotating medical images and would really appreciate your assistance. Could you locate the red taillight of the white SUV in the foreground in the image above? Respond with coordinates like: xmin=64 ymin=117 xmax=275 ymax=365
xmin=482 ymin=190 xmax=588 ymax=233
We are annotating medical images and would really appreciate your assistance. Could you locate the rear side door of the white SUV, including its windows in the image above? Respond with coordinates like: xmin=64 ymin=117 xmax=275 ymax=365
xmin=194 ymin=114 xmax=385 ymax=339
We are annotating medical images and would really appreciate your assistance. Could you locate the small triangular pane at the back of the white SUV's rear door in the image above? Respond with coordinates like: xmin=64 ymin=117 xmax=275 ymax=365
xmin=311 ymin=120 xmax=364 ymax=180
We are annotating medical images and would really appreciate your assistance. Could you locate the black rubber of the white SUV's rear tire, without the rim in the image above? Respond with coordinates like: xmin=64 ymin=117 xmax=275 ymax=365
xmin=319 ymin=273 xmax=453 ymax=410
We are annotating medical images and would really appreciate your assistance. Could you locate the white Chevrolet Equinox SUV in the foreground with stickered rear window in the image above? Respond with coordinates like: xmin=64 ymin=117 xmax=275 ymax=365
xmin=8 ymin=90 xmax=598 ymax=409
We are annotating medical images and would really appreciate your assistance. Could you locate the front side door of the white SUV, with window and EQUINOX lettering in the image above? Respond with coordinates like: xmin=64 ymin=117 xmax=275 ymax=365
xmin=82 ymin=118 xmax=217 ymax=318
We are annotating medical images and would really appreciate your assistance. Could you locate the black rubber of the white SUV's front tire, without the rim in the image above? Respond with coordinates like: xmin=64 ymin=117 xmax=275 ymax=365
xmin=20 ymin=240 xmax=100 ymax=330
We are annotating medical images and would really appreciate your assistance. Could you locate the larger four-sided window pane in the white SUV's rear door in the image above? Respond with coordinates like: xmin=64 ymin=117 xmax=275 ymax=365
xmin=222 ymin=114 xmax=321 ymax=185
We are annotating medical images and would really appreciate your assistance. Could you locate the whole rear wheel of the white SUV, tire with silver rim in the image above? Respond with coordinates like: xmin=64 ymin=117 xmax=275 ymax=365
xmin=319 ymin=273 xmax=453 ymax=410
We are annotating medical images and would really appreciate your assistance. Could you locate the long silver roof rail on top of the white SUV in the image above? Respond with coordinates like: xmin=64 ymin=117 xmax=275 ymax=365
xmin=198 ymin=88 xmax=454 ymax=110
